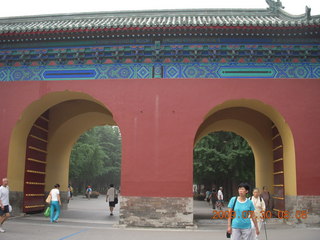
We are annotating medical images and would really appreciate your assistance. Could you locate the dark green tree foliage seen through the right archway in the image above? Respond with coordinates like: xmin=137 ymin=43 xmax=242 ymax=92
xmin=194 ymin=132 xmax=255 ymax=192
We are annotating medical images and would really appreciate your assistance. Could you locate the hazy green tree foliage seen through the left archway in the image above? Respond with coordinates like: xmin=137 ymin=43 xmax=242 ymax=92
xmin=69 ymin=126 xmax=121 ymax=192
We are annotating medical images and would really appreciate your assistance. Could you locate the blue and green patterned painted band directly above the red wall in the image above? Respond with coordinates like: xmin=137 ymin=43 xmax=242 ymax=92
xmin=0 ymin=63 xmax=320 ymax=82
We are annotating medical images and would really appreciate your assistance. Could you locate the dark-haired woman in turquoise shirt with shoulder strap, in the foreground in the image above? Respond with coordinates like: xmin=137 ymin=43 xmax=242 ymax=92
xmin=227 ymin=183 xmax=260 ymax=240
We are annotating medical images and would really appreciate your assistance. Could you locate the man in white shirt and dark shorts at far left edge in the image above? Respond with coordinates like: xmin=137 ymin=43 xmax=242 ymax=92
xmin=0 ymin=178 xmax=10 ymax=233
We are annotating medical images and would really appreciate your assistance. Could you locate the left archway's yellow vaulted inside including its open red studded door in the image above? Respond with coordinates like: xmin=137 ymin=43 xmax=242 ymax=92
xmin=8 ymin=91 xmax=117 ymax=213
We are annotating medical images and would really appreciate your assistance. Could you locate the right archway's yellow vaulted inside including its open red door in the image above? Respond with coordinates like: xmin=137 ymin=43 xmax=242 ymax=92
xmin=194 ymin=99 xmax=297 ymax=218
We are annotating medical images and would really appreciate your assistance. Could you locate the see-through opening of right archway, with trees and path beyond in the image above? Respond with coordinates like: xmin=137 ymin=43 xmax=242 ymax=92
xmin=193 ymin=131 xmax=255 ymax=221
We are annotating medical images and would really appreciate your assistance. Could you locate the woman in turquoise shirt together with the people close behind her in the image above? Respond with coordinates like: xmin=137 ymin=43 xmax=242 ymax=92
xmin=227 ymin=183 xmax=270 ymax=240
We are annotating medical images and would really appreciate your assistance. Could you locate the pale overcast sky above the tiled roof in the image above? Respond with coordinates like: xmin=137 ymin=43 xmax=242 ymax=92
xmin=0 ymin=0 xmax=320 ymax=18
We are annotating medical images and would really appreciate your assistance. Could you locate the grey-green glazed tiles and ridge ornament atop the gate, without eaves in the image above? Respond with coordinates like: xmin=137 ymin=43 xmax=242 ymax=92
xmin=0 ymin=0 xmax=320 ymax=34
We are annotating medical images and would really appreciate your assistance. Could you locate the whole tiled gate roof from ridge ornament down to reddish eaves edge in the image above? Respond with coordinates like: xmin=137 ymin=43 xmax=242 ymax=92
xmin=0 ymin=0 xmax=320 ymax=39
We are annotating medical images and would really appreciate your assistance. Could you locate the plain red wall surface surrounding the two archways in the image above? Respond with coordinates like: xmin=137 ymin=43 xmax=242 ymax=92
xmin=0 ymin=79 xmax=320 ymax=197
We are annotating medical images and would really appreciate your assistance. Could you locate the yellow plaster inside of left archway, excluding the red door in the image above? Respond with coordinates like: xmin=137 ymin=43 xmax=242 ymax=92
xmin=7 ymin=91 xmax=116 ymax=192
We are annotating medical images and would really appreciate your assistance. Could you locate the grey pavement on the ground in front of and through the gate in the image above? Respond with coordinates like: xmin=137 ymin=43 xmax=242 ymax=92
xmin=0 ymin=196 xmax=320 ymax=240
